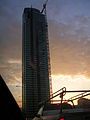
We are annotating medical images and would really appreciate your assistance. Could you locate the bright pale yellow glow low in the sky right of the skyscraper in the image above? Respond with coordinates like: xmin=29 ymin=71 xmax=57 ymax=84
xmin=52 ymin=74 xmax=90 ymax=104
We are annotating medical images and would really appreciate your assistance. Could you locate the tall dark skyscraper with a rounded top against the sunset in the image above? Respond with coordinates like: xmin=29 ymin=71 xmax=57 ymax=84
xmin=22 ymin=8 xmax=50 ymax=118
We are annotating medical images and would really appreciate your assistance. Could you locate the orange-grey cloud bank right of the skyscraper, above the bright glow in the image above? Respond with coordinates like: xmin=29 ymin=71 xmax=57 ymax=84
xmin=49 ymin=17 xmax=90 ymax=76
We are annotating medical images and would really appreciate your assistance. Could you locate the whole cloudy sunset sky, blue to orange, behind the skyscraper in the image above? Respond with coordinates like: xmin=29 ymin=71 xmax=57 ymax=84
xmin=0 ymin=0 xmax=90 ymax=104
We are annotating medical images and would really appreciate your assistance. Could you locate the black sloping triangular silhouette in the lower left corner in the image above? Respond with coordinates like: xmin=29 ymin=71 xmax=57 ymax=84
xmin=0 ymin=76 xmax=25 ymax=120
